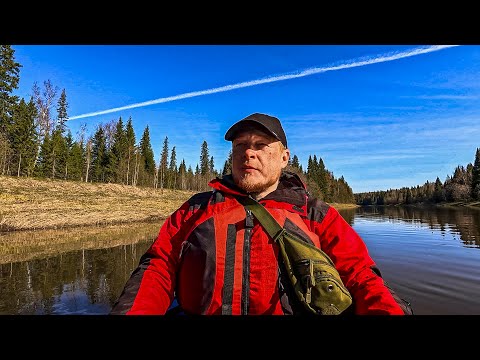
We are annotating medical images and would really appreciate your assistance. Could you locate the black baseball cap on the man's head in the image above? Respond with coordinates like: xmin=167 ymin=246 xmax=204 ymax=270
xmin=225 ymin=113 xmax=287 ymax=148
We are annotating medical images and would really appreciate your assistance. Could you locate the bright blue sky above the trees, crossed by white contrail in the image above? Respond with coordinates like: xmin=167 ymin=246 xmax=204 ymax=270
xmin=12 ymin=45 xmax=480 ymax=193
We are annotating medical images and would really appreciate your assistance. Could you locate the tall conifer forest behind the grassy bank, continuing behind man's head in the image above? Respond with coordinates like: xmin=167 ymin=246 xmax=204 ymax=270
xmin=0 ymin=45 xmax=355 ymax=203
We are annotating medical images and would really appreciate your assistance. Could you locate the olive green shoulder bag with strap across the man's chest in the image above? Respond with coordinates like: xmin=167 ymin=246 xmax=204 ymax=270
xmin=237 ymin=196 xmax=352 ymax=315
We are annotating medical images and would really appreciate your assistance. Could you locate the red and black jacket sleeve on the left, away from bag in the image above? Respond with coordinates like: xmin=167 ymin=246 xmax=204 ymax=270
xmin=110 ymin=202 xmax=189 ymax=315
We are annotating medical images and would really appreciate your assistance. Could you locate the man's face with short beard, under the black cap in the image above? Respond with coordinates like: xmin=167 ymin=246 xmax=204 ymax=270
xmin=232 ymin=129 xmax=290 ymax=198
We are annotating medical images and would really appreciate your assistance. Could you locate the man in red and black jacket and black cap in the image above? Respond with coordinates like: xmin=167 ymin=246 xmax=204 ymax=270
xmin=111 ymin=113 xmax=405 ymax=315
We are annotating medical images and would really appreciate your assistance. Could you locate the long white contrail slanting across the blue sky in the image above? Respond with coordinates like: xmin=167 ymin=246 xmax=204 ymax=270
xmin=69 ymin=45 xmax=459 ymax=120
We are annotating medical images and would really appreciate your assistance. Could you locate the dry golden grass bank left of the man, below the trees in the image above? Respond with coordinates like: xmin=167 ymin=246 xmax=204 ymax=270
xmin=0 ymin=176 xmax=193 ymax=231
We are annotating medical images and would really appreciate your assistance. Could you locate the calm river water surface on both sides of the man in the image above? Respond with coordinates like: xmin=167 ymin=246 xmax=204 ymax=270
xmin=0 ymin=207 xmax=480 ymax=315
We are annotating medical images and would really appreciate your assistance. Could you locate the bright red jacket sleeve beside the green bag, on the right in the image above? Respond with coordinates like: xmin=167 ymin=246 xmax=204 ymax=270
xmin=311 ymin=202 xmax=404 ymax=315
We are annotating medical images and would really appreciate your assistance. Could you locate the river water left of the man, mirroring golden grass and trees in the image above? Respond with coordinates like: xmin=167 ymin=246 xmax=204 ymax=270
xmin=0 ymin=223 xmax=160 ymax=315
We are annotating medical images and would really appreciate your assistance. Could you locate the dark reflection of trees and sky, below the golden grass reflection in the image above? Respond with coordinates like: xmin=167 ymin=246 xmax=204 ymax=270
xmin=0 ymin=241 xmax=151 ymax=315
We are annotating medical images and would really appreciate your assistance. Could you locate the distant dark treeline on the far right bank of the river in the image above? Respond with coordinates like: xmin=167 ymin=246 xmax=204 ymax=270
xmin=355 ymin=148 xmax=480 ymax=205
